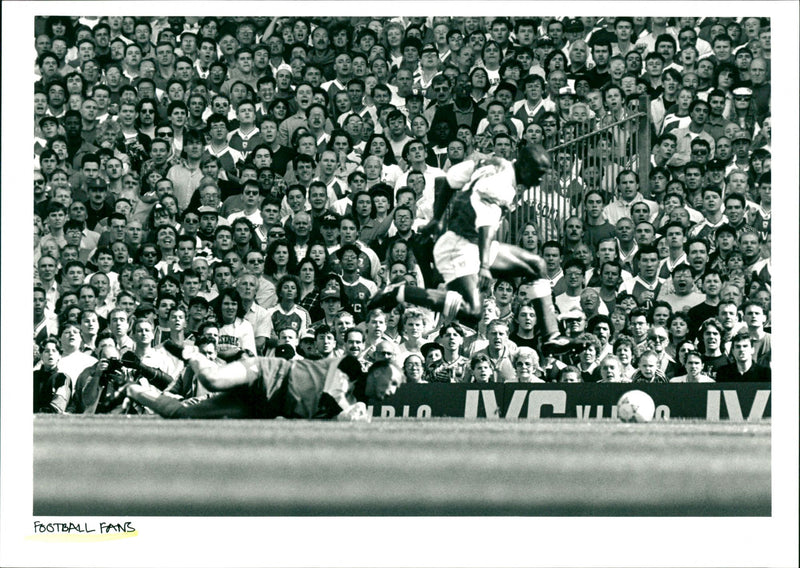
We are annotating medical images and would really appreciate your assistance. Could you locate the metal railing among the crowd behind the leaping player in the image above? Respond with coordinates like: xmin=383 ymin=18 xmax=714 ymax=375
xmin=504 ymin=95 xmax=651 ymax=244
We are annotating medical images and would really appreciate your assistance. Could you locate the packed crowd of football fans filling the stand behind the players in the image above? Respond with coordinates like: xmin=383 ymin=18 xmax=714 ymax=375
xmin=33 ymin=16 xmax=772 ymax=413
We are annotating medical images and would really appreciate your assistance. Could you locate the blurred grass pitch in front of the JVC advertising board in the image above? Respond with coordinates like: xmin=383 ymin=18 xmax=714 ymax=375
xmin=33 ymin=416 xmax=771 ymax=516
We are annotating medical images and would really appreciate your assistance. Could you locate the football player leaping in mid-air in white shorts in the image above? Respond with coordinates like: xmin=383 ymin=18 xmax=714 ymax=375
xmin=369 ymin=146 xmax=572 ymax=353
